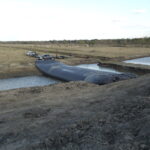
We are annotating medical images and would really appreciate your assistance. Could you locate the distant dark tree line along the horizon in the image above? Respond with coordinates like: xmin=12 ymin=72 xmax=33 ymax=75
xmin=0 ymin=37 xmax=150 ymax=47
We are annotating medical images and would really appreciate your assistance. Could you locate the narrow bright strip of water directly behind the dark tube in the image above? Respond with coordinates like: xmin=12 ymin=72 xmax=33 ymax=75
xmin=78 ymin=64 xmax=120 ymax=74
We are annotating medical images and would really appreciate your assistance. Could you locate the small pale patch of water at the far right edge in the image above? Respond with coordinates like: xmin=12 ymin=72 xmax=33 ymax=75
xmin=124 ymin=57 xmax=150 ymax=65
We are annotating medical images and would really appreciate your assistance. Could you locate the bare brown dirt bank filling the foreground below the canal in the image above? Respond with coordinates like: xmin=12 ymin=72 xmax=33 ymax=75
xmin=0 ymin=75 xmax=150 ymax=150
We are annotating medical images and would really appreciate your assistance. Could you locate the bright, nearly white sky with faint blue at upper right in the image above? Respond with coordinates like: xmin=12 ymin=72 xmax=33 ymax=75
xmin=0 ymin=0 xmax=150 ymax=41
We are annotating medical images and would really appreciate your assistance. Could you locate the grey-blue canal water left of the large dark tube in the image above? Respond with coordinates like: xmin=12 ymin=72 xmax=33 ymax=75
xmin=0 ymin=76 xmax=60 ymax=91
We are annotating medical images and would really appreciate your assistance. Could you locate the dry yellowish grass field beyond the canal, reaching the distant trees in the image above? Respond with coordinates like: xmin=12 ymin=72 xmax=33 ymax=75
xmin=0 ymin=43 xmax=150 ymax=78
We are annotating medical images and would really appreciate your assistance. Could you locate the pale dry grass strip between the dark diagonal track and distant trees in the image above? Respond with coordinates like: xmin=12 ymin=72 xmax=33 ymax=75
xmin=0 ymin=44 xmax=150 ymax=60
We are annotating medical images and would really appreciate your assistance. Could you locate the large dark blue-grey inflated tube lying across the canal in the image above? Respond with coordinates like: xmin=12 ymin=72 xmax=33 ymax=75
xmin=35 ymin=60 xmax=135 ymax=84
